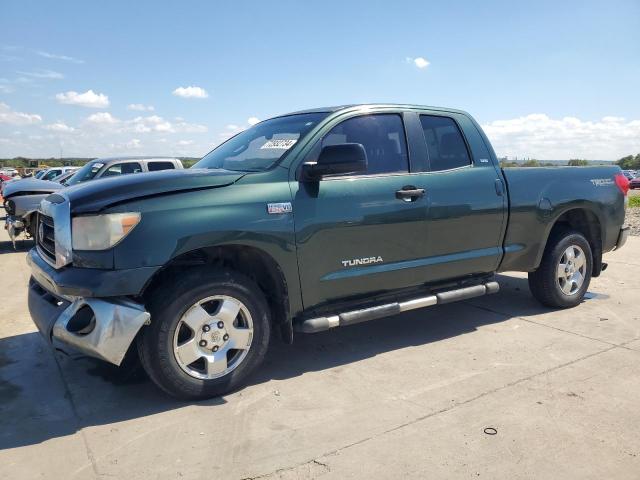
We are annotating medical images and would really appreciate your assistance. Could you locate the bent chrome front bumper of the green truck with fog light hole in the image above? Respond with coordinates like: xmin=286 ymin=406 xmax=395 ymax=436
xmin=29 ymin=278 xmax=150 ymax=365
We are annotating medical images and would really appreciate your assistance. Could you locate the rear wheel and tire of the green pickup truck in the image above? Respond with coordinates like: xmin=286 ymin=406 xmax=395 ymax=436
xmin=529 ymin=230 xmax=593 ymax=308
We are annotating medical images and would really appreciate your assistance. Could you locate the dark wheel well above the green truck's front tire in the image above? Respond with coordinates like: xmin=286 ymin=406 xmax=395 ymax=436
xmin=142 ymin=245 xmax=293 ymax=343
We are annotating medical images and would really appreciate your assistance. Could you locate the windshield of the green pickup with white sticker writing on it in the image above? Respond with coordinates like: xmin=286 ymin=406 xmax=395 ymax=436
xmin=193 ymin=113 xmax=327 ymax=172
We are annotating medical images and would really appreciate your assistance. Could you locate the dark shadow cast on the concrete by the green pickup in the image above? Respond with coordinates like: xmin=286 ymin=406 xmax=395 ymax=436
xmin=0 ymin=276 xmax=604 ymax=449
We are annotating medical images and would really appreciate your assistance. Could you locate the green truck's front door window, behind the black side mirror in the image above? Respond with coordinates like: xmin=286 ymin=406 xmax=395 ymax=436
xmin=318 ymin=114 xmax=409 ymax=174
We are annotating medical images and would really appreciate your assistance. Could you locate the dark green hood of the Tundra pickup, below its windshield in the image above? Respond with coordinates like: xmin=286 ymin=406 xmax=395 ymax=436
xmin=64 ymin=168 xmax=246 ymax=213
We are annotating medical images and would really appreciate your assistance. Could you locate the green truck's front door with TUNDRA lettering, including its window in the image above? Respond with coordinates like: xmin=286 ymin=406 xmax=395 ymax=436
xmin=292 ymin=113 xmax=427 ymax=309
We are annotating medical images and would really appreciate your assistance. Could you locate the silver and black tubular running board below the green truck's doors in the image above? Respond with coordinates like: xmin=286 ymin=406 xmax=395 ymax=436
xmin=294 ymin=282 xmax=500 ymax=333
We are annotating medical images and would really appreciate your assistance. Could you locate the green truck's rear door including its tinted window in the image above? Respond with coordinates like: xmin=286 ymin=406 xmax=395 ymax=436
xmin=407 ymin=112 xmax=507 ymax=282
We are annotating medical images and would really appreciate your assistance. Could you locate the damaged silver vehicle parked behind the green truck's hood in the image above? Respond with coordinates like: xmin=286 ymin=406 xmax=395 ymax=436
xmin=2 ymin=157 xmax=183 ymax=246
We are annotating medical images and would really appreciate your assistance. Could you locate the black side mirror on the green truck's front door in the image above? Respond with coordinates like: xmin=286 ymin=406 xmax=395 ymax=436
xmin=302 ymin=143 xmax=367 ymax=182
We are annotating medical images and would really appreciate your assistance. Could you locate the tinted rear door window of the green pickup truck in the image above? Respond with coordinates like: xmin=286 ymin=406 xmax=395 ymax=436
xmin=420 ymin=115 xmax=471 ymax=172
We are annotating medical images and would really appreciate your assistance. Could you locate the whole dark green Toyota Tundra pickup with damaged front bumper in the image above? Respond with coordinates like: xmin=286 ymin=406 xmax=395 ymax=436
xmin=27 ymin=105 xmax=628 ymax=399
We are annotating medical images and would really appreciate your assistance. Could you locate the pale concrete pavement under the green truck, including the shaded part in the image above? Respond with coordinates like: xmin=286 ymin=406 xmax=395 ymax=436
xmin=0 ymin=228 xmax=640 ymax=479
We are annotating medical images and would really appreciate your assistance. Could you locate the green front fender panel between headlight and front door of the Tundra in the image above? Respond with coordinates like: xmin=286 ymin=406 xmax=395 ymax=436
xmin=110 ymin=174 xmax=301 ymax=313
